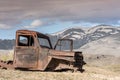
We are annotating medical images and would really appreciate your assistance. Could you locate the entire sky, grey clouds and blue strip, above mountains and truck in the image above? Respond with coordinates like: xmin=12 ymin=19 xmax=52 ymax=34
xmin=0 ymin=0 xmax=120 ymax=39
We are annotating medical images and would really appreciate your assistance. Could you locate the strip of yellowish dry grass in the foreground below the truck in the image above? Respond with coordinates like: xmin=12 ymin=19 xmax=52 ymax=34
xmin=0 ymin=66 xmax=120 ymax=80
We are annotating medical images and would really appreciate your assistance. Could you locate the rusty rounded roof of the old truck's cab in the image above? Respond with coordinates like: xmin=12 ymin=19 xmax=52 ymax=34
xmin=16 ymin=30 xmax=49 ymax=39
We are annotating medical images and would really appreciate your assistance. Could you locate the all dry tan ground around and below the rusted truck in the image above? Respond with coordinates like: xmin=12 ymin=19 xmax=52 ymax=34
xmin=0 ymin=51 xmax=120 ymax=80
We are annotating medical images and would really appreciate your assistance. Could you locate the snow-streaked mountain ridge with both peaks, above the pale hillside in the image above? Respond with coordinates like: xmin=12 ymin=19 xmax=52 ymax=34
xmin=52 ymin=25 xmax=120 ymax=49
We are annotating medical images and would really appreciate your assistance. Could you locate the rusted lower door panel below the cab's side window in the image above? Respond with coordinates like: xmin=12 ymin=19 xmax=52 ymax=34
xmin=15 ymin=47 xmax=38 ymax=68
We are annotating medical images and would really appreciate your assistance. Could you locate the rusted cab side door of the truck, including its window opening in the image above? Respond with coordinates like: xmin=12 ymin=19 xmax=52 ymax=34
xmin=15 ymin=34 xmax=38 ymax=68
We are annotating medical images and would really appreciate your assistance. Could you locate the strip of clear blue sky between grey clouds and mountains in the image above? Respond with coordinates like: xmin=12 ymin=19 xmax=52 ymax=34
xmin=0 ymin=20 xmax=96 ymax=39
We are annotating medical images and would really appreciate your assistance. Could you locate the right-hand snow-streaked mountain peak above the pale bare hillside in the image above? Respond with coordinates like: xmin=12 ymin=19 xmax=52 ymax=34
xmin=87 ymin=25 xmax=120 ymax=41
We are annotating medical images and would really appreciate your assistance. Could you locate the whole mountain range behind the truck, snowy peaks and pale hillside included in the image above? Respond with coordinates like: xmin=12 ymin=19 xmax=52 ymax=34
xmin=0 ymin=25 xmax=120 ymax=54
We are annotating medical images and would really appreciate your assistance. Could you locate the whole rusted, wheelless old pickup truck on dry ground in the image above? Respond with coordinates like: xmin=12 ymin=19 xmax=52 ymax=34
xmin=0 ymin=30 xmax=85 ymax=71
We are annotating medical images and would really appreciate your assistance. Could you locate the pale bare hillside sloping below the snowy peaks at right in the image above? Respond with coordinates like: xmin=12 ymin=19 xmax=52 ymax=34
xmin=80 ymin=33 xmax=120 ymax=56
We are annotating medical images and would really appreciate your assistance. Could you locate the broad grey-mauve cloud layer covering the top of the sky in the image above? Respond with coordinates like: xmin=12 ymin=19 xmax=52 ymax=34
xmin=0 ymin=0 xmax=120 ymax=27
